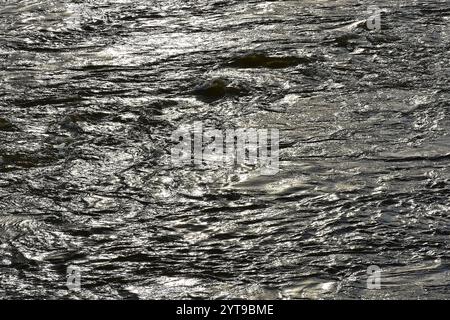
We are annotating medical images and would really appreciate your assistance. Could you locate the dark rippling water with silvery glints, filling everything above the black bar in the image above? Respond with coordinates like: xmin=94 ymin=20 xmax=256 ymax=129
xmin=0 ymin=0 xmax=450 ymax=299
